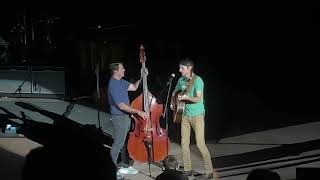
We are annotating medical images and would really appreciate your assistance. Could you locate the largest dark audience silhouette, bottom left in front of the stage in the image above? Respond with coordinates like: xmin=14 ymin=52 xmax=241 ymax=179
xmin=22 ymin=120 xmax=117 ymax=180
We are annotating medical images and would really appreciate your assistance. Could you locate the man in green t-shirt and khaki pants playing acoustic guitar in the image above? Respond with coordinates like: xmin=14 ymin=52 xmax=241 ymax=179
xmin=170 ymin=58 xmax=213 ymax=179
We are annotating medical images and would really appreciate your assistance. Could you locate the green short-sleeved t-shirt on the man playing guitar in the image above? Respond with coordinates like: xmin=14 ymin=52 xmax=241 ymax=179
xmin=175 ymin=76 xmax=205 ymax=116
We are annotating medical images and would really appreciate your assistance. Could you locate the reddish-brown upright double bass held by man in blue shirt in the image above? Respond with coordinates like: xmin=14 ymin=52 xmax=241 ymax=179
xmin=128 ymin=45 xmax=170 ymax=163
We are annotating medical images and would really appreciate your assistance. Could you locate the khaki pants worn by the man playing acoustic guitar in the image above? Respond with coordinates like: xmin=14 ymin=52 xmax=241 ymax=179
xmin=181 ymin=115 xmax=213 ymax=174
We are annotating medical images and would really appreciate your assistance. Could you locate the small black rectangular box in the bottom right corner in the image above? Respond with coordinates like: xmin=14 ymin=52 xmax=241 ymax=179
xmin=296 ymin=167 xmax=320 ymax=180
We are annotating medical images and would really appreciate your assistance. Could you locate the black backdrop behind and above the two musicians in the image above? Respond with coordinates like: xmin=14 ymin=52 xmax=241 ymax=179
xmin=1 ymin=6 xmax=320 ymax=140
